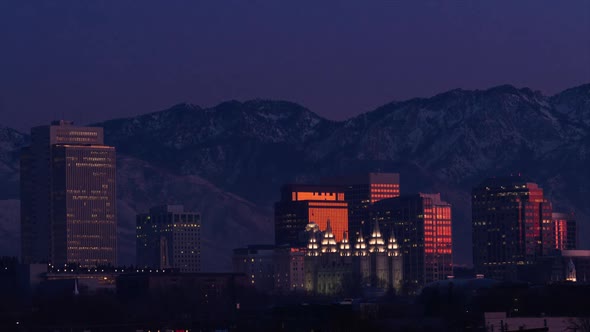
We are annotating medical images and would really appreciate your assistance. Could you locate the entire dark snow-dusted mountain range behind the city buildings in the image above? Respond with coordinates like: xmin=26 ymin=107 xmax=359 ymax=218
xmin=0 ymin=84 xmax=590 ymax=271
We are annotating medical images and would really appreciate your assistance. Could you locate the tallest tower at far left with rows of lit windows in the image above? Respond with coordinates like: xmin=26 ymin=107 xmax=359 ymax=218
xmin=20 ymin=121 xmax=117 ymax=266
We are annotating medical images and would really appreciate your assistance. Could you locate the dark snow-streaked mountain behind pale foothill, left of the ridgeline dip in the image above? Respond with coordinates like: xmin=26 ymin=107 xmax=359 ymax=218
xmin=99 ymin=100 xmax=337 ymax=203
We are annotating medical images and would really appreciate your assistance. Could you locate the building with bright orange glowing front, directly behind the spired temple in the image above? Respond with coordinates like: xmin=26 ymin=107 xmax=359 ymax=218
xmin=275 ymin=184 xmax=348 ymax=247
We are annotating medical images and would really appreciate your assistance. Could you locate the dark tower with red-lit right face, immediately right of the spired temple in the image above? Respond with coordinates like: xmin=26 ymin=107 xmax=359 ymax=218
xmin=371 ymin=193 xmax=453 ymax=293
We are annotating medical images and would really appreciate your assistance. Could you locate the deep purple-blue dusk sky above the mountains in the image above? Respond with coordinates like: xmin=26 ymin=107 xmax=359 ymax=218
xmin=0 ymin=0 xmax=590 ymax=130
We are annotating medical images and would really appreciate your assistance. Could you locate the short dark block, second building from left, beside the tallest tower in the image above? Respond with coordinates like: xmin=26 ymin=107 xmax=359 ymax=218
xmin=136 ymin=205 xmax=201 ymax=272
